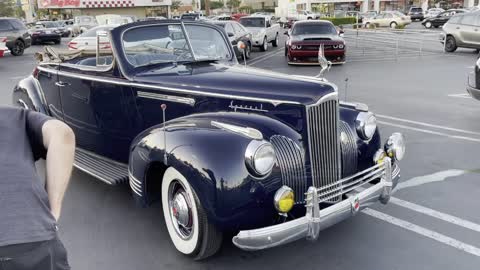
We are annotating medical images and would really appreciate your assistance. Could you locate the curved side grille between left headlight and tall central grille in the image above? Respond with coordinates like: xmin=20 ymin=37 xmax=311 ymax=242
xmin=270 ymin=135 xmax=307 ymax=203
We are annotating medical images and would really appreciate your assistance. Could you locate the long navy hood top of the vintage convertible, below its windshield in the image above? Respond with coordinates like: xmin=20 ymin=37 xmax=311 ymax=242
xmin=132 ymin=63 xmax=336 ymax=105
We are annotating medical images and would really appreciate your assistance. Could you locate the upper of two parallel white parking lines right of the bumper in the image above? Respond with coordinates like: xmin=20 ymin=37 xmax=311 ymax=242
xmin=389 ymin=197 xmax=480 ymax=232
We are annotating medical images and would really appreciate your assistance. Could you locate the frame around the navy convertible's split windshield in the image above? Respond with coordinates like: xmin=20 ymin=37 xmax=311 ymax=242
xmin=118 ymin=21 xmax=236 ymax=71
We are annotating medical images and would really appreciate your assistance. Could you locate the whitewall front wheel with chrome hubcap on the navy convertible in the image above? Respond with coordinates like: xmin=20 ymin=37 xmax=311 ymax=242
xmin=162 ymin=167 xmax=222 ymax=260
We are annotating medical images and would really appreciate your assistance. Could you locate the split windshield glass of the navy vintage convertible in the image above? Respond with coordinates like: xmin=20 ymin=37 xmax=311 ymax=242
xmin=122 ymin=25 xmax=232 ymax=67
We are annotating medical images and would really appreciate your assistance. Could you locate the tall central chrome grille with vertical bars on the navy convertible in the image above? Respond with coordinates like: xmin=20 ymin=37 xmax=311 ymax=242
xmin=307 ymin=99 xmax=341 ymax=202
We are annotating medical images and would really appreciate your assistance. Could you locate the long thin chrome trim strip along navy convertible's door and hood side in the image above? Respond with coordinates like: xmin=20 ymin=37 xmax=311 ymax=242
xmin=37 ymin=66 xmax=301 ymax=106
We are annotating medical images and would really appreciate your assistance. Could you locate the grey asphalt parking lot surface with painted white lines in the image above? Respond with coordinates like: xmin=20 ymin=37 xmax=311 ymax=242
xmin=0 ymin=24 xmax=480 ymax=270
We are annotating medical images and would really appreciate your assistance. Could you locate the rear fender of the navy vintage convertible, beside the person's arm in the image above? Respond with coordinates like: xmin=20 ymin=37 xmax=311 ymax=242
xmin=12 ymin=75 xmax=49 ymax=115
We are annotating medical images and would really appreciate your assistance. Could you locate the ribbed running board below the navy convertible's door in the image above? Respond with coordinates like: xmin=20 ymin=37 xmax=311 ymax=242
xmin=73 ymin=148 xmax=128 ymax=185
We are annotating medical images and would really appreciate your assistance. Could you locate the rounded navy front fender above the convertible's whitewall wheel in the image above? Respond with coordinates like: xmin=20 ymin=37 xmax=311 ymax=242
xmin=129 ymin=112 xmax=300 ymax=228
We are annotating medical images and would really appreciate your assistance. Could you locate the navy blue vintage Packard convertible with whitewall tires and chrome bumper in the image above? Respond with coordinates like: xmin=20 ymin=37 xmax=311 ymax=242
xmin=13 ymin=20 xmax=405 ymax=259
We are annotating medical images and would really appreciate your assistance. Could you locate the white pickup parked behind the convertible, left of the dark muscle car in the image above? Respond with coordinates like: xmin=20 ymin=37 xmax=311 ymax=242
xmin=239 ymin=15 xmax=281 ymax=51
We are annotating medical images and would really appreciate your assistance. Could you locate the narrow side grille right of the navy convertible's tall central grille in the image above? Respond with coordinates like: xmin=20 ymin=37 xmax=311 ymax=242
xmin=340 ymin=121 xmax=358 ymax=178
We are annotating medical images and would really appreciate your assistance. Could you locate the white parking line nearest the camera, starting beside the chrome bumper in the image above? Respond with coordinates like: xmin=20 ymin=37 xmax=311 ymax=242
xmin=362 ymin=208 xmax=480 ymax=257
